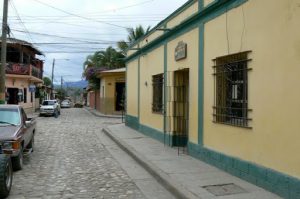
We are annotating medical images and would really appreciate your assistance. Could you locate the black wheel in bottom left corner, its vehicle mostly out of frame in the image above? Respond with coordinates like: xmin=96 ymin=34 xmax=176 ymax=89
xmin=0 ymin=154 xmax=13 ymax=198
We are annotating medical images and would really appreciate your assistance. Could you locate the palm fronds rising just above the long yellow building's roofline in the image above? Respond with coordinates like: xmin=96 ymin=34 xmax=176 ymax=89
xmin=118 ymin=25 xmax=150 ymax=53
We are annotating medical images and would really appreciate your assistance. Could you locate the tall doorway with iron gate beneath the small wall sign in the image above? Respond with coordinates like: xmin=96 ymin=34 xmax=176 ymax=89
xmin=173 ymin=69 xmax=189 ymax=147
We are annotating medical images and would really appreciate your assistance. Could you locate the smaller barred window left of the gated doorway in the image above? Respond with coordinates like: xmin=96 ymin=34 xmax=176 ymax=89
xmin=152 ymin=74 xmax=164 ymax=113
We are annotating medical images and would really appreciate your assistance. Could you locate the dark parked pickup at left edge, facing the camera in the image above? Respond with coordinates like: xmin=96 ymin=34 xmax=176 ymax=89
xmin=0 ymin=105 xmax=36 ymax=172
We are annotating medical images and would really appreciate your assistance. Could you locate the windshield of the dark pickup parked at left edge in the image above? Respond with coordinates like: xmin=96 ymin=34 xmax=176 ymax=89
xmin=0 ymin=108 xmax=21 ymax=126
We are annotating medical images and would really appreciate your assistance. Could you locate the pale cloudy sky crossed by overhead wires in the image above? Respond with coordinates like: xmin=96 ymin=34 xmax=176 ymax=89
xmin=0 ymin=0 xmax=187 ymax=84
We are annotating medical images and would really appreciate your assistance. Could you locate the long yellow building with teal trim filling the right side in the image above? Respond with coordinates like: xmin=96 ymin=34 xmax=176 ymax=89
xmin=126 ymin=0 xmax=300 ymax=198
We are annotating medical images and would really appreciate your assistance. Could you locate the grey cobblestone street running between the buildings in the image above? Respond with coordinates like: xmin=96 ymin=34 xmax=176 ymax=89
xmin=9 ymin=109 xmax=145 ymax=199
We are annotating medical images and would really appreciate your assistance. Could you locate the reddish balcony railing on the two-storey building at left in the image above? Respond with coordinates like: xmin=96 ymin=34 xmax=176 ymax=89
xmin=5 ymin=63 xmax=43 ymax=79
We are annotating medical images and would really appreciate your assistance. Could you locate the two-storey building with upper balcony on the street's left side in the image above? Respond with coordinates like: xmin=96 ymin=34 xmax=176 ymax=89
xmin=5 ymin=38 xmax=44 ymax=112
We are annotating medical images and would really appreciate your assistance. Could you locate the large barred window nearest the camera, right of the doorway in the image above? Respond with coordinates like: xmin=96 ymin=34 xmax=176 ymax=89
xmin=213 ymin=51 xmax=251 ymax=127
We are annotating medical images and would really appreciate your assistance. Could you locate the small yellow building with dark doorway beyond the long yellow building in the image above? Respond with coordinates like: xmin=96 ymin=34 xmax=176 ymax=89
xmin=97 ymin=68 xmax=126 ymax=115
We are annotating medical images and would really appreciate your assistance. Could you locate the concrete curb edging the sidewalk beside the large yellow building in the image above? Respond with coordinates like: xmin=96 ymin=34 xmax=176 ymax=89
xmin=102 ymin=128 xmax=199 ymax=199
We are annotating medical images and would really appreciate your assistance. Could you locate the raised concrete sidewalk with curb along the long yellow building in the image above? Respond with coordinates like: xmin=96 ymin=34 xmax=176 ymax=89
xmin=103 ymin=124 xmax=280 ymax=199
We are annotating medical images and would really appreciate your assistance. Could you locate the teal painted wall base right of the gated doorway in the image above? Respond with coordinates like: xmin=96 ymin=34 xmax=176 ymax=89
xmin=188 ymin=142 xmax=300 ymax=199
